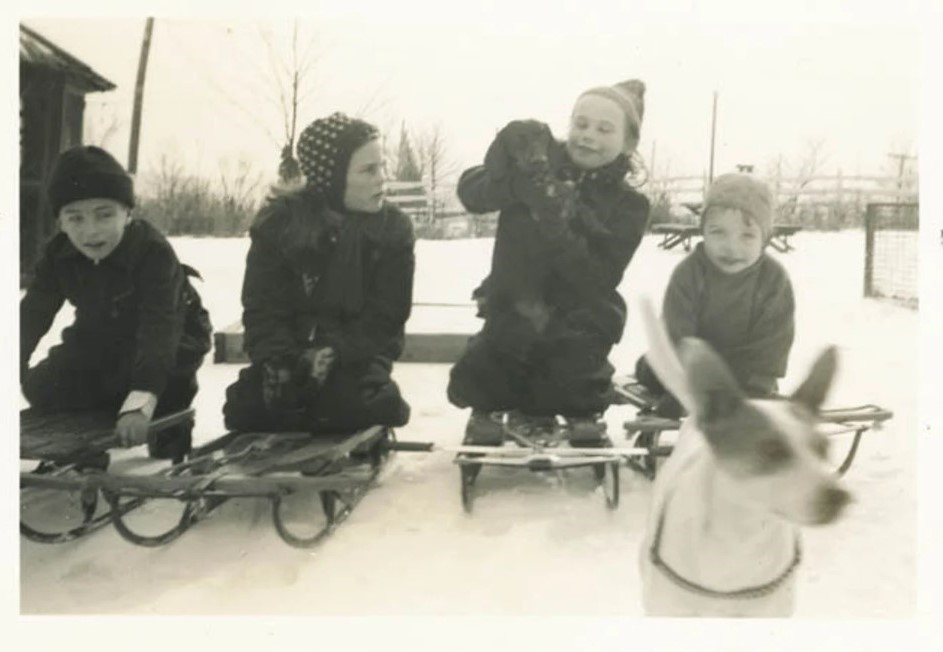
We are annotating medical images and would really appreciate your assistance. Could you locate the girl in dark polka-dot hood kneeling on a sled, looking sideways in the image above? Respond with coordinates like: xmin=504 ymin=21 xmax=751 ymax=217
xmin=223 ymin=113 xmax=415 ymax=432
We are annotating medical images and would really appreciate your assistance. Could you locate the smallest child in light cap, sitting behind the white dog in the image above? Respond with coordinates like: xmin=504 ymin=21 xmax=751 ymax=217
xmin=636 ymin=174 xmax=795 ymax=416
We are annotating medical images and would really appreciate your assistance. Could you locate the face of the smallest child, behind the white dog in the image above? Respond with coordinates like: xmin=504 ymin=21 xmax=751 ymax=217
xmin=704 ymin=207 xmax=764 ymax=274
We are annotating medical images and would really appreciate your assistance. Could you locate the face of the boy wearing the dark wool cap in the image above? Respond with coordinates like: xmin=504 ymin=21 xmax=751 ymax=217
xmin=59 ymin=199 xmax=131 ymax=261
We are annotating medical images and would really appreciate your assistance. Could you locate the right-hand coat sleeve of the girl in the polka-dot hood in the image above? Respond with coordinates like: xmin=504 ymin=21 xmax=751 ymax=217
xmin=326 ymin=214 xmax=416 ymax=365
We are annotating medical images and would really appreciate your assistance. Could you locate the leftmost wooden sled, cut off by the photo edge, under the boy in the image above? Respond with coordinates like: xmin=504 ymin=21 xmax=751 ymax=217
xmin=20 ymin=408 xmax=195 ymax=543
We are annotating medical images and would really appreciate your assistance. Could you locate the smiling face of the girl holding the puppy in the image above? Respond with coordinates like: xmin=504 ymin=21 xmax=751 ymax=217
xmin=566 ymin=94 xmax=626 ymax=170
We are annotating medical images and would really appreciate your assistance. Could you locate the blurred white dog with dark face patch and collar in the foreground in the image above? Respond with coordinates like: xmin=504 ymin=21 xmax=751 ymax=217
xmin=640 ymin=304 xmax=850 ymax=617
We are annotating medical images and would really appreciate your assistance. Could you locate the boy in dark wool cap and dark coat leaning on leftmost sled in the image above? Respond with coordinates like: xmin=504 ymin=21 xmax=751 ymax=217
xmin=20 ymin=146 xmax=212 ymax=464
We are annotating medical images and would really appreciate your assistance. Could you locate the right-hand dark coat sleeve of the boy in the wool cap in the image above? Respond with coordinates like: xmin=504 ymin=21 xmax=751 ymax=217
xmin=131 ymin=239 xmax=184 ymax=396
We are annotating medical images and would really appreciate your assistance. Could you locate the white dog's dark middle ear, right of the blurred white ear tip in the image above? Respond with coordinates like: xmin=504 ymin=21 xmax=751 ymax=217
xmin=678 ymin=338 xmax=746 ymax=429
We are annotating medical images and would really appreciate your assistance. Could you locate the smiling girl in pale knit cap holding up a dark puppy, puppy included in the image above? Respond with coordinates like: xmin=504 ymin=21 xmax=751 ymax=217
xmin=448 ymin=80 xmax=649 ymax=445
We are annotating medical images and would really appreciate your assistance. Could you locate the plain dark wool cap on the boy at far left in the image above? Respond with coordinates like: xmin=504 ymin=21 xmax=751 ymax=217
xmin=47 ymin=145 xmax=134 ymax=216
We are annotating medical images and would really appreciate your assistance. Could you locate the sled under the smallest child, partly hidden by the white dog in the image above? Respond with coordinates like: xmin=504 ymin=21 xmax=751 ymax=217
xmin=614 ymin=376 xmax=894 ymax=479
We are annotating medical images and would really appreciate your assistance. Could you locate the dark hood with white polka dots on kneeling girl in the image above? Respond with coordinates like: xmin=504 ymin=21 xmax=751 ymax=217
xmin=298 ymin=111 xmax=380 ymax=205
